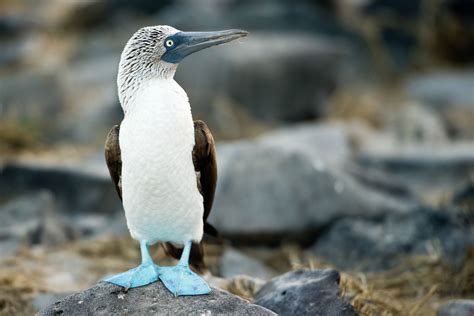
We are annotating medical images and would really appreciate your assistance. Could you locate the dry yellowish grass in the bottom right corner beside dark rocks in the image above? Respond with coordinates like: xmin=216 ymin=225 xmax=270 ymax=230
xmin=284 ymin=249 xmax=474 ymax=315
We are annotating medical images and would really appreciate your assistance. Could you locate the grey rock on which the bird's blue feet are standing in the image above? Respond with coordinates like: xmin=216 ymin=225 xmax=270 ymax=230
xmin=38 ymin=282 xmax=274 ymax=315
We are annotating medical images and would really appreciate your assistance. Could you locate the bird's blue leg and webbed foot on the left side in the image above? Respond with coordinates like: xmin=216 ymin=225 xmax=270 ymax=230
xmin=104 ymin=241 xmax=159 ymax=290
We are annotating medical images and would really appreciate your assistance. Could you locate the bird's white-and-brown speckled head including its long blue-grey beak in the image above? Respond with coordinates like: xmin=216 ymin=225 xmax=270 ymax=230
xmin=117 ymin=25 xmax=248 ymax=105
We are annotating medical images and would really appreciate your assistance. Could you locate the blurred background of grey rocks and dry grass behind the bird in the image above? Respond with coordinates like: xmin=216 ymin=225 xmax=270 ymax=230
xmin=0 ymin=0 xmax=474 ymax=315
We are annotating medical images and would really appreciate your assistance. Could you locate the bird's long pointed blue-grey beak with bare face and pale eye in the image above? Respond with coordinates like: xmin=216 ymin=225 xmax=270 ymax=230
xmin=161 ymin=30 xmax=248 ymax=64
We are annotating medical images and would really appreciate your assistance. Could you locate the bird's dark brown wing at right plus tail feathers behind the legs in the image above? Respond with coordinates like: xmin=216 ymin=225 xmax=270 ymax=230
xmin=163 ymin=121 xmax=217 ymax=273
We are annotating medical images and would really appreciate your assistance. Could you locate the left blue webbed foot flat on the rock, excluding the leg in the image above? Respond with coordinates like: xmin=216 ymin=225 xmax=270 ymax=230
xmin=104 ymin=264 xmax=158 ymax=289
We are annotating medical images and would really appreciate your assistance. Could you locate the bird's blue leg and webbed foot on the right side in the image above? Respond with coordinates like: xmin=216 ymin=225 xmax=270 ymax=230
xmin=160 ymin=241 xmax=211 ymax=296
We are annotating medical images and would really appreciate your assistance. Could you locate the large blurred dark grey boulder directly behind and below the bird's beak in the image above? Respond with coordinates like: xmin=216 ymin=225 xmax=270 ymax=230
xmin=176 ymin=33 xmax=349 ymax=127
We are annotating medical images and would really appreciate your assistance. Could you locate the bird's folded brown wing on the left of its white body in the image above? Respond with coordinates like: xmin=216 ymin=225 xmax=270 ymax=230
xmin=105 ymin=125 xmax=122 ymax=199
